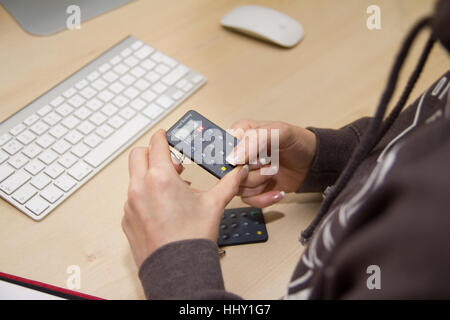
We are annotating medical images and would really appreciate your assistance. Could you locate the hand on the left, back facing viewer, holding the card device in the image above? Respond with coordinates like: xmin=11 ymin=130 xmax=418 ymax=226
xmin=122 ymin=130 xmax=248 ymax=267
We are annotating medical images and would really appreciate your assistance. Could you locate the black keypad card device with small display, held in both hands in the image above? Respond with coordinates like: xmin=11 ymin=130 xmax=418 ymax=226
xmin=166 ymin=110 xmax=239 ymax=179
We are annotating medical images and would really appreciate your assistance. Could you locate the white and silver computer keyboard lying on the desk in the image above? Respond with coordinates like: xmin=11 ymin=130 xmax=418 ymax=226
xmin=0 ymin=36 xmax=206 ymax=220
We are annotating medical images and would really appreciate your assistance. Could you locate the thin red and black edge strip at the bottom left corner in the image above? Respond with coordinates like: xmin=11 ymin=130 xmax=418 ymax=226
xmin=0 ymin=272 xmax=104 ymax=300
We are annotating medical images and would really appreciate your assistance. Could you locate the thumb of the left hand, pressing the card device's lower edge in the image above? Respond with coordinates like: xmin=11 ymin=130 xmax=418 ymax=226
xmin=208 ymin=165 xmax=249 ymax=207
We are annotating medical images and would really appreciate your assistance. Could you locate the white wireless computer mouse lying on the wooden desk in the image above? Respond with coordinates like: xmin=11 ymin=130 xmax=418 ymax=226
xmin=221 ymin=5 xmax=304 ymax=48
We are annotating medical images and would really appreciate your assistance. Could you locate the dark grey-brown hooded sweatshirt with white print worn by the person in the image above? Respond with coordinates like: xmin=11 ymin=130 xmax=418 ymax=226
xmin=139 ymin=72 xmax=450 ymax=299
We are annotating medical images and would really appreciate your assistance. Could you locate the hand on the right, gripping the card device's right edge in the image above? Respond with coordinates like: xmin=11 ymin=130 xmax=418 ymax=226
xmin=227 ymin=120 xmax=316 ymax=208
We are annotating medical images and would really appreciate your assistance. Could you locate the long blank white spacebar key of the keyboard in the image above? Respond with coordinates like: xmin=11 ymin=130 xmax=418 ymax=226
xmin=84 ymin=115 xmax=151 ymax=167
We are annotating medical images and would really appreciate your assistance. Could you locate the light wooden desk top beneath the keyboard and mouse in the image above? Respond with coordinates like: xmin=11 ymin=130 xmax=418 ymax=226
xmin=0 ymin=0 xmax=449 ymax=299
